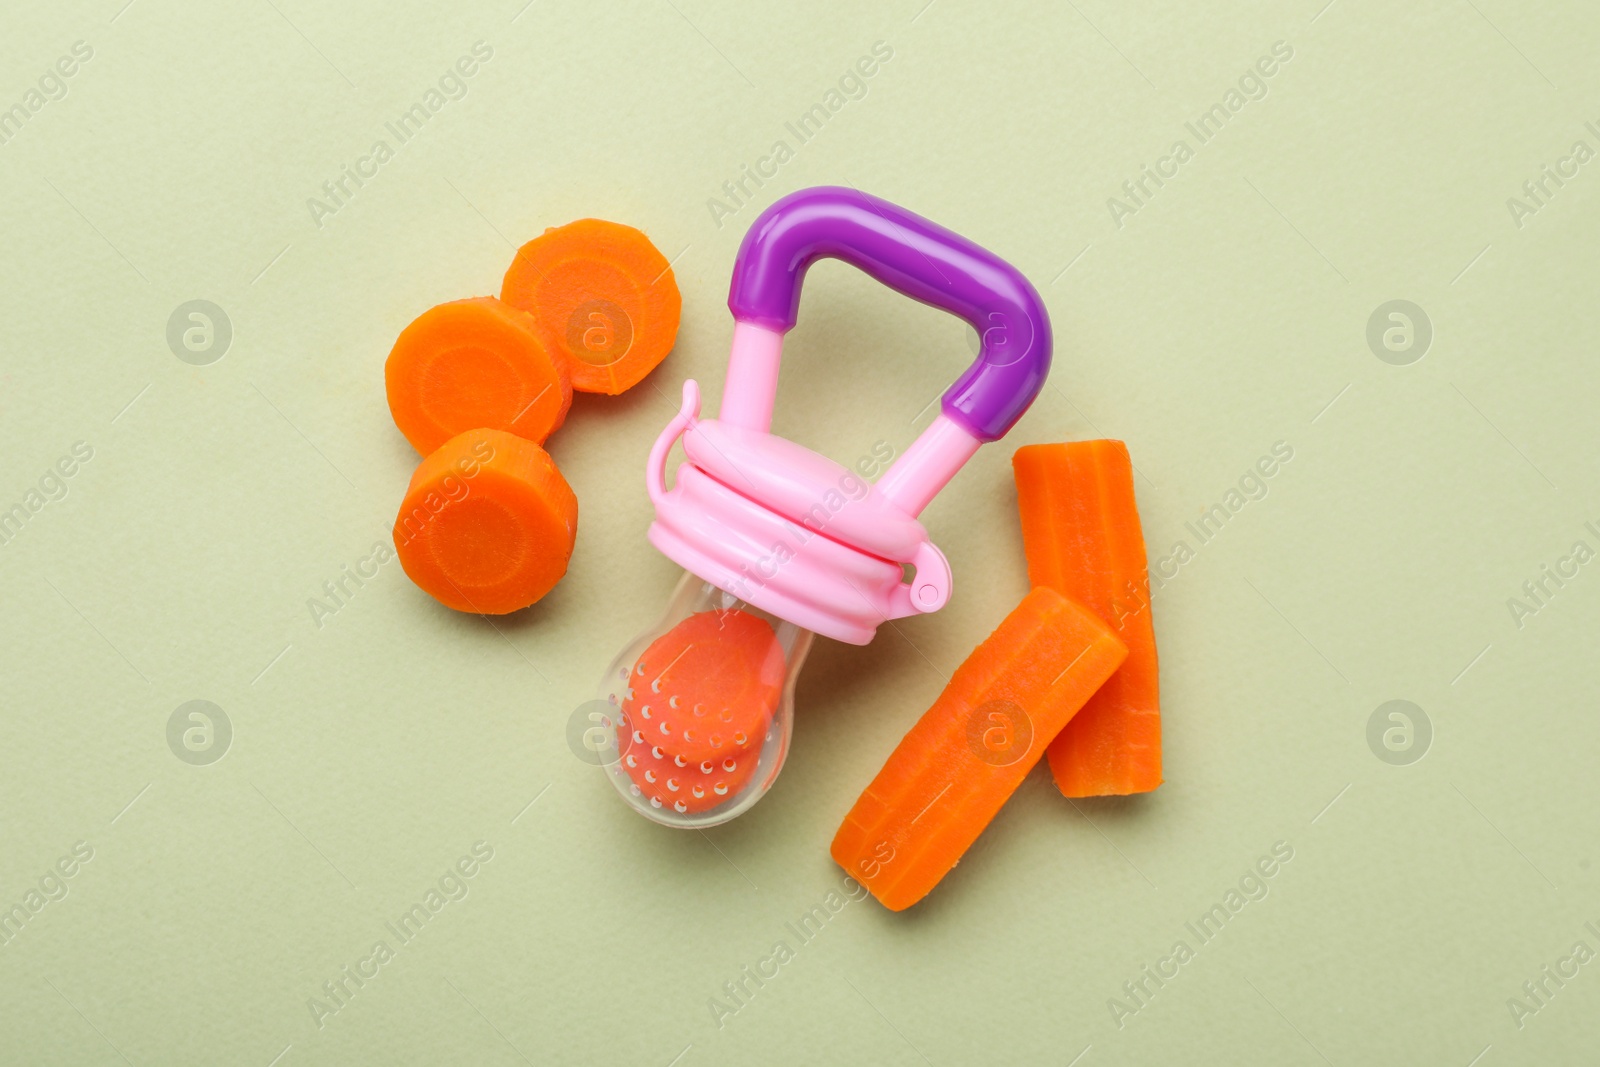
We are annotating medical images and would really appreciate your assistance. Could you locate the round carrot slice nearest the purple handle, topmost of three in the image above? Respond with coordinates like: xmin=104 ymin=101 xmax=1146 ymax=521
xmin=501 ymin=219 xmax=683 ymax=397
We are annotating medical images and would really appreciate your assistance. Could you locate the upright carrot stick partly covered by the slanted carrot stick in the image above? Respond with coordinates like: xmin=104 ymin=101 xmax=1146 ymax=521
xmin=1011 ymin=442 xmax=1162 ymax=797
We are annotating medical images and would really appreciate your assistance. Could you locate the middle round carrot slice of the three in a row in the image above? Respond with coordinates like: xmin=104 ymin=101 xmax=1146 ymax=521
xmin=384 ymin=296 xmax=573 ymax=456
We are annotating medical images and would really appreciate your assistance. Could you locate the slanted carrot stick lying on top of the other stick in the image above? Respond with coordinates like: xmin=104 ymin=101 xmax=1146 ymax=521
xmin=832 ymin=589 xmax=1128 ymax=912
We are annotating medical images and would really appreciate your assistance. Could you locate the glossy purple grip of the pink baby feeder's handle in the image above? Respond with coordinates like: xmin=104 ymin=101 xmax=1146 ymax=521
xmin=728 ymin=186 xmax=1051 ymax=442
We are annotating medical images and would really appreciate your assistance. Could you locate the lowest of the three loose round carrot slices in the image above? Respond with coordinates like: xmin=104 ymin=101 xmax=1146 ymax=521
xmin=394 ymin=429 xmax=578 ymax=614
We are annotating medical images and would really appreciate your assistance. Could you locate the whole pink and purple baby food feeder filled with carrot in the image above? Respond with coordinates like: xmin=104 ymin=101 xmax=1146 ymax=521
xmin=600 ymin=187 xmax=1051 ymax=827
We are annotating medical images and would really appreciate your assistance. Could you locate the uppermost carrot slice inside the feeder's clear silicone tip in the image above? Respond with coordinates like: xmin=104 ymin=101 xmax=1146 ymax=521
xmin=622 ymin=611 xmax=786 ymax=763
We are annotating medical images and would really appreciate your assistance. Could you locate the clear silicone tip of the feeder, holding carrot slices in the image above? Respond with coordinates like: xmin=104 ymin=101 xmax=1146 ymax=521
xmin=600 ymin=573 xmax=811 ymax=829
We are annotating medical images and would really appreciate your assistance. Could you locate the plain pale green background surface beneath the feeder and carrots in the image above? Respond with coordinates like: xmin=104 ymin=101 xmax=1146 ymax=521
xmin=0 ymin=0 xmax=1600 ymax=1067
